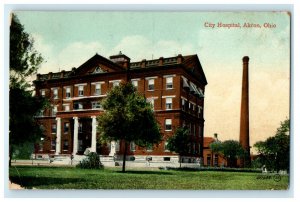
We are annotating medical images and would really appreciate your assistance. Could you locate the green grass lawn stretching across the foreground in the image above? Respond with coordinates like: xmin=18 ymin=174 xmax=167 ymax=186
xmin=9 ymin=166 xmax=289 ymax=190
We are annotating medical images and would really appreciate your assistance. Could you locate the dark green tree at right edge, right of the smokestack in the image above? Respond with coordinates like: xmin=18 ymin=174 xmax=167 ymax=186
xmin=254 ymin=119 xmax=290 ymax=172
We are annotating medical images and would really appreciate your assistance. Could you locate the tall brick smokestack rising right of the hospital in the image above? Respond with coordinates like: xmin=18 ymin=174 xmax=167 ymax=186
xmin=240 ymin=56 xmax=251 ymax=167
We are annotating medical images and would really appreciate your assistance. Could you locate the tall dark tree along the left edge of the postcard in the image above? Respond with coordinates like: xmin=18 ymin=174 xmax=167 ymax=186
xmin=9 ymin=14 xmax=48 ymax=165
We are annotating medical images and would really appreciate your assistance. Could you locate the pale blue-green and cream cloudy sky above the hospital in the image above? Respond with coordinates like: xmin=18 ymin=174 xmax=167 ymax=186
xmin=15 ymin=11 xmax=290 ymax=152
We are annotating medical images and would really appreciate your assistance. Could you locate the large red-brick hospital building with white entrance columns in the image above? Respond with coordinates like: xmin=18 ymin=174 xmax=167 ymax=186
xmin=34 ymin=52 xmax=207 ymax=161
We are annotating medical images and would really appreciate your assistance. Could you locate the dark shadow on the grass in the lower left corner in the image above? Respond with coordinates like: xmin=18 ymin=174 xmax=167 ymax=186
xmin=10 ymin=176 xmax=82 ymax=189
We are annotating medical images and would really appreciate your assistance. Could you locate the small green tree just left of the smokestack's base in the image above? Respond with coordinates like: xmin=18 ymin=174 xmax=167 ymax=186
xmin=222 ymin=140 xmax=245 ymax=167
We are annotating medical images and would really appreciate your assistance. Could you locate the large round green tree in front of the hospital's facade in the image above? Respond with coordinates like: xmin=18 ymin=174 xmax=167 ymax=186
xmin=97 ymin=82 xmax=162 ymax=172
